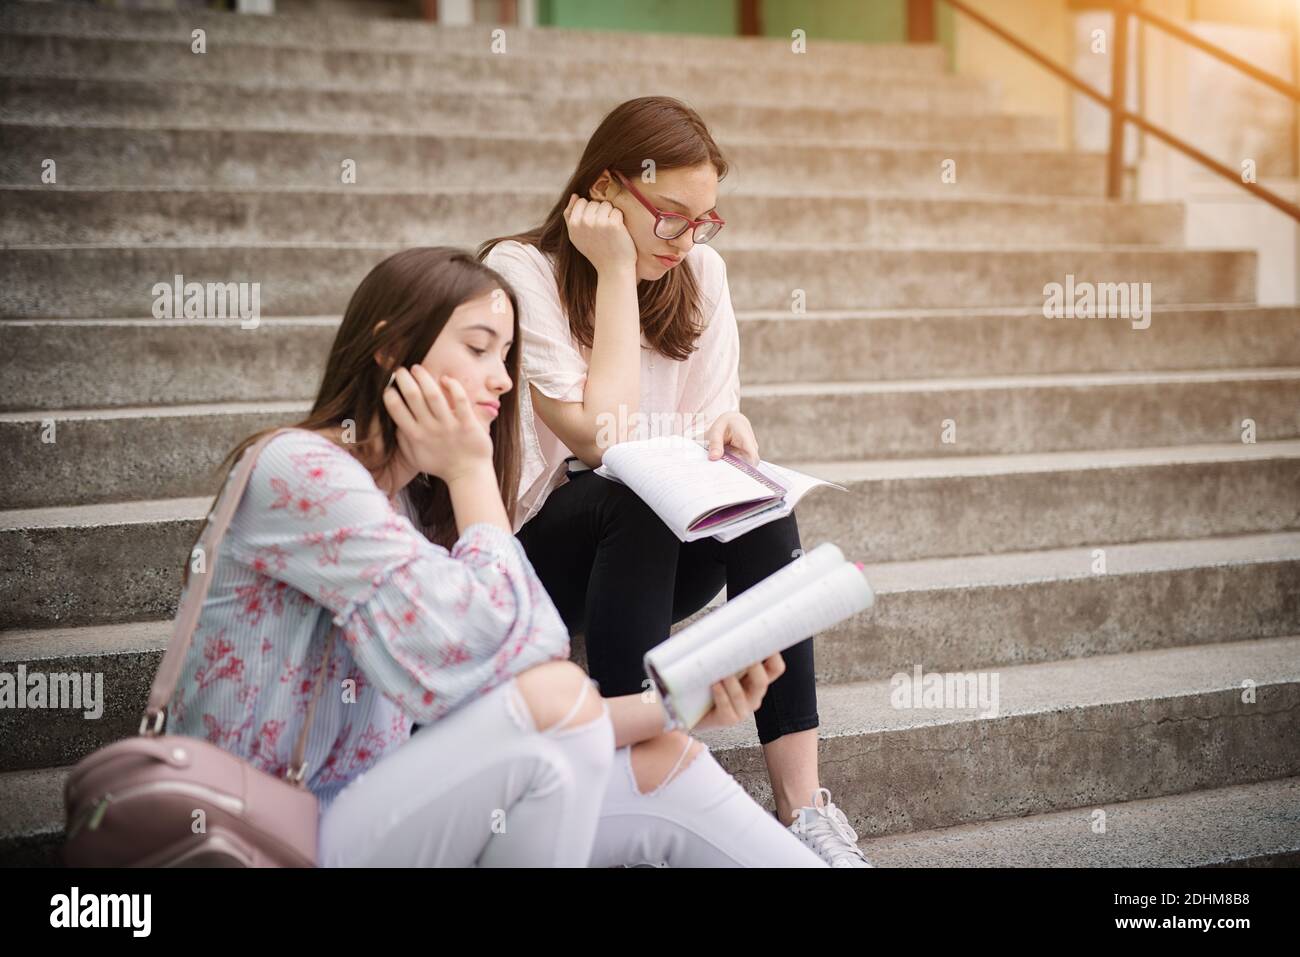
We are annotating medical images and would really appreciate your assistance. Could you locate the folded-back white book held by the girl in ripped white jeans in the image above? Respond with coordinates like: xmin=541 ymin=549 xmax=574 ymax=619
xmin=645 ymin=542 xmax=875 ymax=728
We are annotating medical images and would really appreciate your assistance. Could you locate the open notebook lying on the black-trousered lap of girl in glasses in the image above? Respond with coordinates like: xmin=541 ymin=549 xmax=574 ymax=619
xmin=595 ymin=436 xmax=846 ymax=542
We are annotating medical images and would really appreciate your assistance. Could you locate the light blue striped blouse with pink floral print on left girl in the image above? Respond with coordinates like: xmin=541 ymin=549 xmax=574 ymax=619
xmin=168 ymin=429 xmax=569 ymax=807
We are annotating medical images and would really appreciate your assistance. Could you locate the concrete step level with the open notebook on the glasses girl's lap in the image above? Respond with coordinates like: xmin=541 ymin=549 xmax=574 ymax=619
xmin=0 ymin=442 xmax=1300 ymax=627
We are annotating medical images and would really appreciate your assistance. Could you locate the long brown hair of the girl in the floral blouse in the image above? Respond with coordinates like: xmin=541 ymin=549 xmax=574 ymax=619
xmin=185 ymin=246 xmax=520 ymax=580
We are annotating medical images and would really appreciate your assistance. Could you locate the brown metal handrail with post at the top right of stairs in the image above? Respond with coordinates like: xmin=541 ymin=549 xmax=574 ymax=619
xmin=944 ymin=0 xmax=1300 ymax=222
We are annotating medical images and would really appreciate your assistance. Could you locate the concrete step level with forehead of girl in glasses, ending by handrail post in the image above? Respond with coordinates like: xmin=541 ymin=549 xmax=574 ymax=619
xmin=0 ymin=124 xmax=1105 ymax=197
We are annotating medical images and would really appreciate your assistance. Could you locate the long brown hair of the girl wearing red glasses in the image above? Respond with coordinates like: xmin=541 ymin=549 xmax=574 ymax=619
xmin=478 ymin=96 xmax=728 ymax=359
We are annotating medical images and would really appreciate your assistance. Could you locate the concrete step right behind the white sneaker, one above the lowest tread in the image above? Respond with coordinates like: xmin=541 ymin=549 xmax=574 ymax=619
xmin=699 ymin=636 xmax=1300 ymax=837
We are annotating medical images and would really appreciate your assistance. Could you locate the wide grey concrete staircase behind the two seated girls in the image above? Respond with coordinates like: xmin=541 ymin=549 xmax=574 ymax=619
xmin=0 ymin=3 xmax=1300 ymax=866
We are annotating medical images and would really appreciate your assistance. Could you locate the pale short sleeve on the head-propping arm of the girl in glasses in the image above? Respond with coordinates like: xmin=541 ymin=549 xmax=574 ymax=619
xmin=484 ymin=241 xmax=588 ymax=402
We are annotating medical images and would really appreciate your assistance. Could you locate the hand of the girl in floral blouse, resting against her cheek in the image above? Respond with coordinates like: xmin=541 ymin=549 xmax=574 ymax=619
xmin=384 ymin=365 xmax=493 ymax=485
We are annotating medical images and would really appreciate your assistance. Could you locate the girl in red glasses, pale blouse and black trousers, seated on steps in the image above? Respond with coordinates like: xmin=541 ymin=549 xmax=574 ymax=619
xmin=478 ymin=96 xmax=870 ymax=867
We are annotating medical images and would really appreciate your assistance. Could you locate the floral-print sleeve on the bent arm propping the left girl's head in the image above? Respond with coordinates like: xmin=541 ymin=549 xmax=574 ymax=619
xmin=228 ymin=430 xmax=569 ymax=723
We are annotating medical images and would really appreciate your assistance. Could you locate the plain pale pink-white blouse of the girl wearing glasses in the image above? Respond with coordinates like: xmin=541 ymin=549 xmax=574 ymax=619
xmin=484 ymin=241 xmax=740 ymax=532
